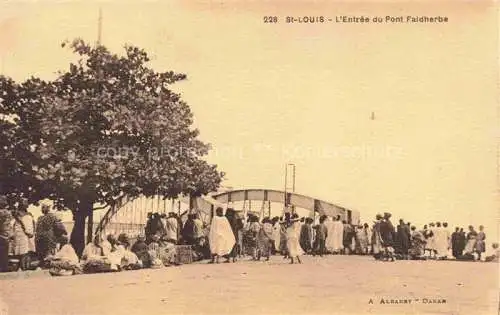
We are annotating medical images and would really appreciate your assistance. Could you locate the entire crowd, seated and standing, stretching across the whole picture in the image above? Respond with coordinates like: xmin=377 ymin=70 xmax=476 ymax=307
xmin=0 ymin=196 xmax=499 ymax=275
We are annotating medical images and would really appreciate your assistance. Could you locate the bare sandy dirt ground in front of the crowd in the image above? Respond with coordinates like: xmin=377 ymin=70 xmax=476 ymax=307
xmin=0 ymin=256 xmax=499 ymax=315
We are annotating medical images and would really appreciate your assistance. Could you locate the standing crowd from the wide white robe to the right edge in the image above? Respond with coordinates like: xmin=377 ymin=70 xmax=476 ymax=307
xmin=205 ymin=209 xmax=500 ymax=263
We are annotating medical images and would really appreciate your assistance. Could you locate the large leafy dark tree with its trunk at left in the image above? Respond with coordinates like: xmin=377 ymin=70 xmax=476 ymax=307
xmin=0 ymin=40 xmax=223 ymax=254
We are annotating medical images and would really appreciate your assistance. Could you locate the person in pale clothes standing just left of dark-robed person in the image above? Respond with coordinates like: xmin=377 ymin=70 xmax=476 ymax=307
xmin=13 ymin=204 xmax=35 ymax=258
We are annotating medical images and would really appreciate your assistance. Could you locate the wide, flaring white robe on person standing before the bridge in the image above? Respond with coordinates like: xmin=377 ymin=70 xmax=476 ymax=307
xmin=208 ymin=216 xmax=236 ymax=256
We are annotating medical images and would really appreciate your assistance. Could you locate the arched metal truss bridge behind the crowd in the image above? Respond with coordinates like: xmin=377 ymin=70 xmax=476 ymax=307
xmin=95 ymin=189 xmax=360 ymax=236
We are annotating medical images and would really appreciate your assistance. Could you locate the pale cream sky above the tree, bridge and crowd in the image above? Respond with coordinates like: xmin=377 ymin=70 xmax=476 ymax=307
xmin=0 ymin=1 xmax=500 ymax=240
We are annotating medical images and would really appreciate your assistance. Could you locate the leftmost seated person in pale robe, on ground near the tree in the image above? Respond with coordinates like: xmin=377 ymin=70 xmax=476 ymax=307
xmin=46 ymin=235 xmax=81 ymax=276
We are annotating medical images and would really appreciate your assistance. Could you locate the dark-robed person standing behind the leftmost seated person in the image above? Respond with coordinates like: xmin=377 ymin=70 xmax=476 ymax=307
xmin=35 ymin=204 xmax=68 ymax=262
